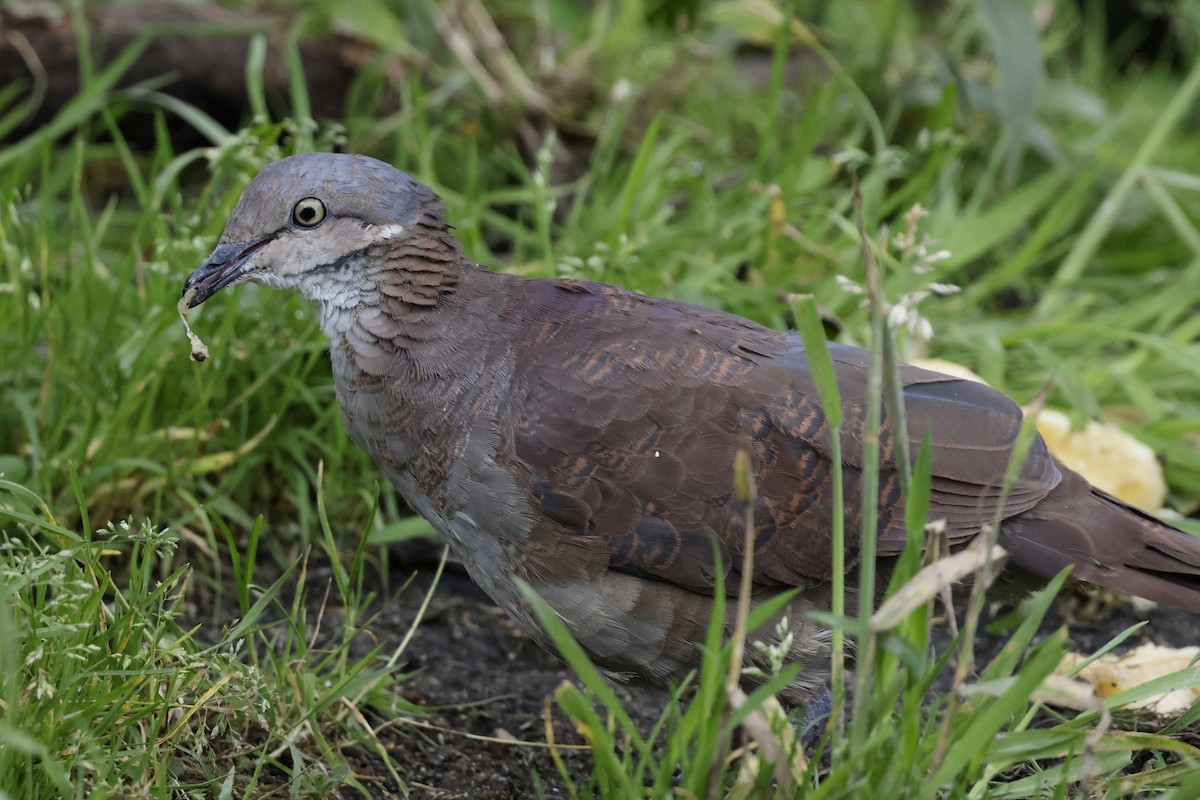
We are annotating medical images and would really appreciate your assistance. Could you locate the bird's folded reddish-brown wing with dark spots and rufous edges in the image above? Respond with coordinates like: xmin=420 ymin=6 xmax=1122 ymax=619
xmin=511 ymin=282 xmax=1060 ymax=590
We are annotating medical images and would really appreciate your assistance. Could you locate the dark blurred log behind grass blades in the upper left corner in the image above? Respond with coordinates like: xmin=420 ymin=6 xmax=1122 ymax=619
xmin=0 ymin=2 xmax=376 ymax=148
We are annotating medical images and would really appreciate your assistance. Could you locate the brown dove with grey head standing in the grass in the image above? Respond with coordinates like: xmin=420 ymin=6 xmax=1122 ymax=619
xmin=181 ymin=154 xmax=1200 ymax=704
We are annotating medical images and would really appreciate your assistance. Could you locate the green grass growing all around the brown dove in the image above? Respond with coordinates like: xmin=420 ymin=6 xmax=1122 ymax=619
xmin=0 ymin=0 xmax=1200 ymax=798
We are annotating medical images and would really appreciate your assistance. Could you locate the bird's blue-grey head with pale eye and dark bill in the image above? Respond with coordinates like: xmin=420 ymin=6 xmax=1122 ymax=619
xmin=184 ymin=152 xmax=452 ymax=308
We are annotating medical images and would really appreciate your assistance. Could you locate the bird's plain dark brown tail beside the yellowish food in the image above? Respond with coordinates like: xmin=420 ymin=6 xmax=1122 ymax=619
xmin=1000 ymin=469 xmax=1200 ymax=613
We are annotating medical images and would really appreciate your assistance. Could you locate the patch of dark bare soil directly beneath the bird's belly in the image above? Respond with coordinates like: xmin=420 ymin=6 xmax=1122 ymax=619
xmin=364 ymin=567 xmax=664 ymax=800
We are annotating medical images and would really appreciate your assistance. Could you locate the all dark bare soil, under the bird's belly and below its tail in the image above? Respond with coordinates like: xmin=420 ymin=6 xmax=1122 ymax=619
xmin=288 ymin=537 xmax=1200 ymax=800
